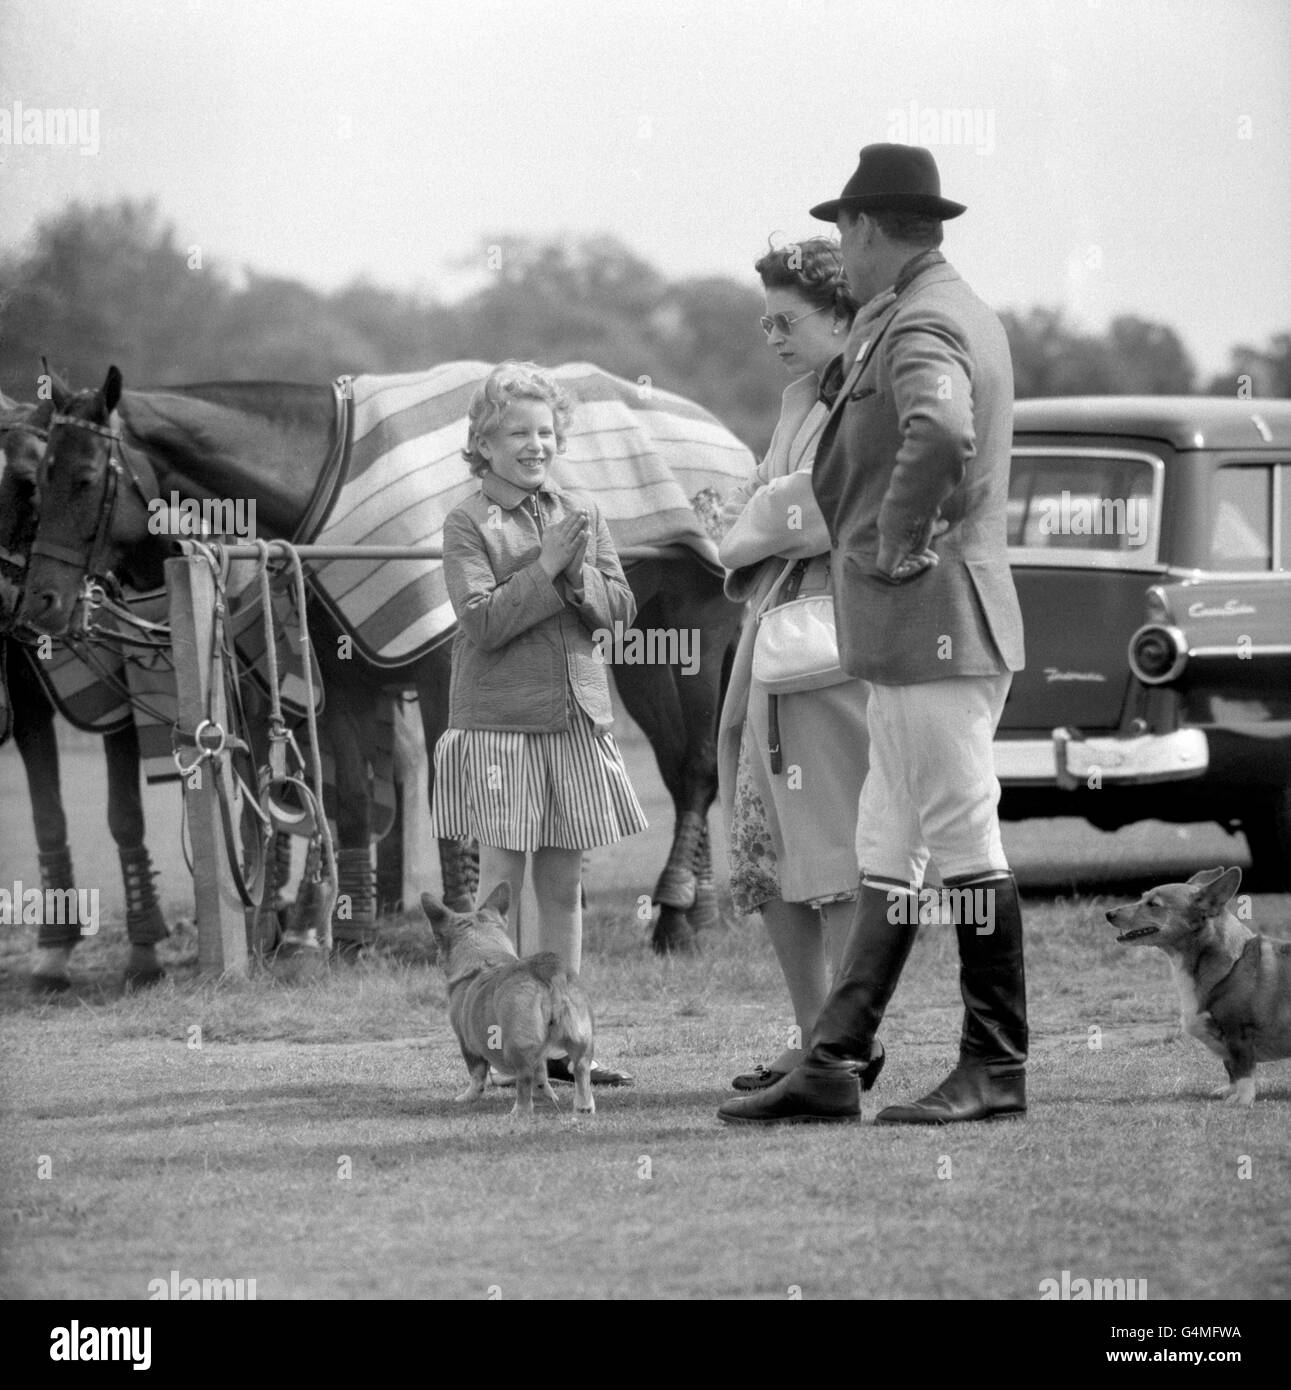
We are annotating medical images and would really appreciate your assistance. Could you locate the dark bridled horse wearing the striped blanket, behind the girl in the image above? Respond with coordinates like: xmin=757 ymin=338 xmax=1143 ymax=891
xmin=21 ymin=367 xmax=752 ymax=952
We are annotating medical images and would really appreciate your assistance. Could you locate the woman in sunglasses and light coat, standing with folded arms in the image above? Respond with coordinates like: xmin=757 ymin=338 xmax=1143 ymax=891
xmin=718 ymin=236 xmax=882 ymax=1091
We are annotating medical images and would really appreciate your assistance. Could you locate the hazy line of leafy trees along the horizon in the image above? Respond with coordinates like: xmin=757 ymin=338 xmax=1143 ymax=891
xmin=0 ymin=200 xmax=1291 ymax=455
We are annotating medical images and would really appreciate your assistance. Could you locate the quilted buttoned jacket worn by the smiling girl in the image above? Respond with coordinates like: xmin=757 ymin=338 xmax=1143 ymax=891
xmin=443 ymin=473 xmax=636 ymax=734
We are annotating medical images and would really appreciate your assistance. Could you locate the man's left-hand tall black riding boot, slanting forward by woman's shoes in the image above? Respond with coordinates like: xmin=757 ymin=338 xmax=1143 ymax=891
xmin=717 ymin=878 xmax=919 ymax=1125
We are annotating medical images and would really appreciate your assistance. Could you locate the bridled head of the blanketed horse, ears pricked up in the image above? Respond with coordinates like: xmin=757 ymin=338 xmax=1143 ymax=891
xmin=18 ymin=367 xmax=157 ymax=637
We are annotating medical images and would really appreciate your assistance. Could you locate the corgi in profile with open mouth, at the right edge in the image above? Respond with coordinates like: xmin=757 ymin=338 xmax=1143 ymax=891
xmin=1108 ymin=869 xmax=1291 ymax=1105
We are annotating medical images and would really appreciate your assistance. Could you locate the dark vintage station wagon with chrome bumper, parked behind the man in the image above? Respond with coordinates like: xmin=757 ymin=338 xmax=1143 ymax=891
xmin=995 ymin=396 xmax=1291 ymax=888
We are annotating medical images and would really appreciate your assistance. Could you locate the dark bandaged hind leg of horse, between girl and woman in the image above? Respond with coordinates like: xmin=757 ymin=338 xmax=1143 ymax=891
xmin=614 ymin=560 xmax=741 ymax=952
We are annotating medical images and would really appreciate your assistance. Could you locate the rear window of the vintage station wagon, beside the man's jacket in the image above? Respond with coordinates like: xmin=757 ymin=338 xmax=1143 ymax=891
xmin=1009 ymin=453 xmax=1153 ymax=552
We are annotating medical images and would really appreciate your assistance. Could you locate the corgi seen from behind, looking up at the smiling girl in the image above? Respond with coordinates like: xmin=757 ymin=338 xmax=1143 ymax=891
xmin=421 ymin=881 xmax=596 ymax=1119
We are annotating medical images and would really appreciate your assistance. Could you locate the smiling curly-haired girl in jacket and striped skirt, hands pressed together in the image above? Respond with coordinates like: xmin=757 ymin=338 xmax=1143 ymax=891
xmin=432 ymin=361 xmax=646 ymax=1086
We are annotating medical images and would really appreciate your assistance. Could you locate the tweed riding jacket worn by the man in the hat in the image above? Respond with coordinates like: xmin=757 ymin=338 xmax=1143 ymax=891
xmin=812 ymin=256 xmax=1024 ymax=685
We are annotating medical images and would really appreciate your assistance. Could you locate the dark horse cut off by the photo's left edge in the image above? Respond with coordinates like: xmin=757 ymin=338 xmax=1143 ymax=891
xmin=0 ymin=402 xmax=170 ymax=995
